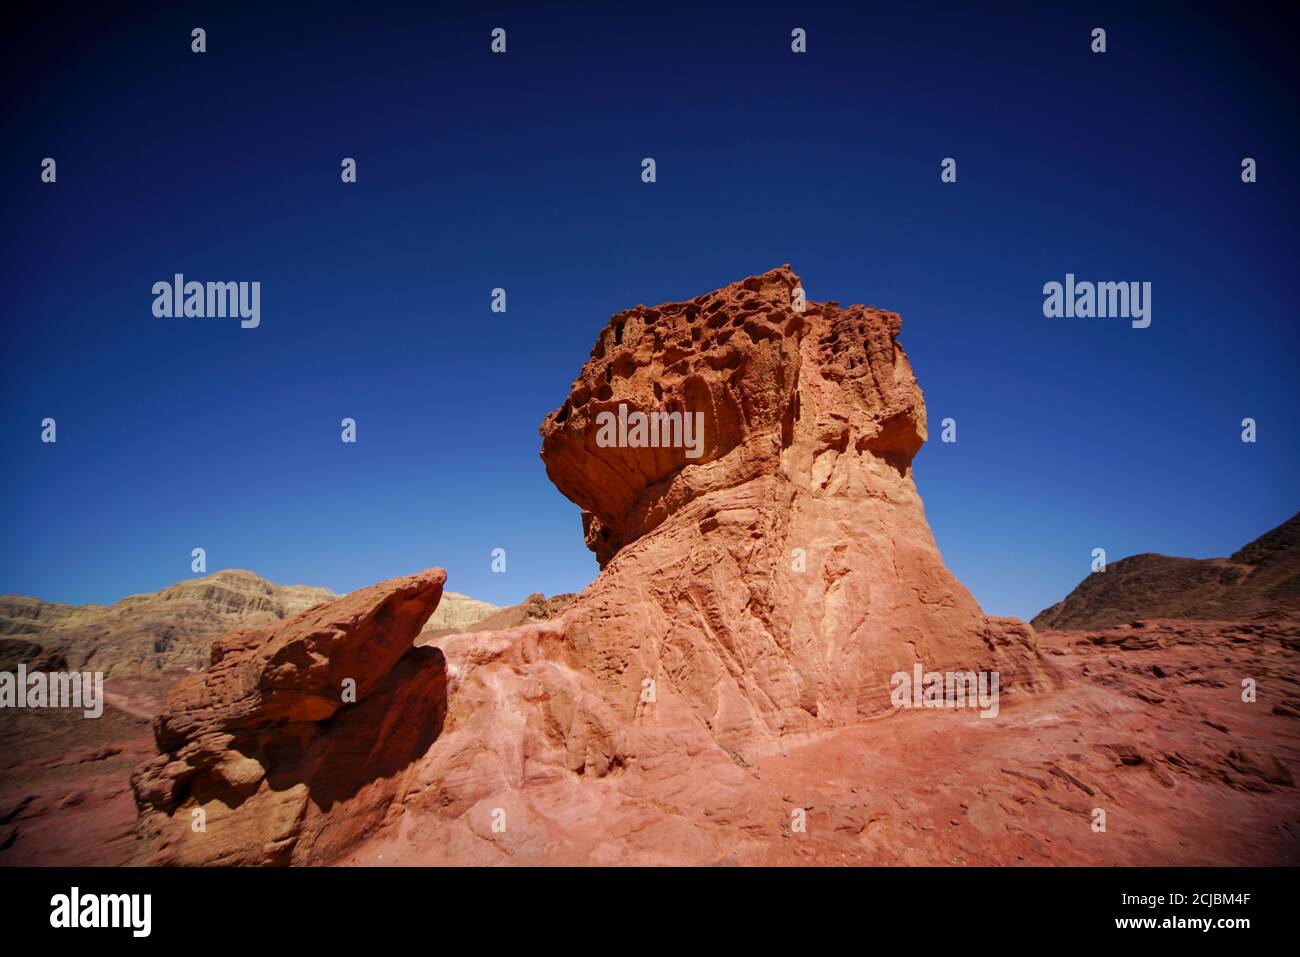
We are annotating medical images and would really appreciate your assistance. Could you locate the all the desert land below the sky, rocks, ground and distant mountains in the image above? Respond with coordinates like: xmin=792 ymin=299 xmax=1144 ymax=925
xmin=0 ymin=267 xmax=1300 ymax=866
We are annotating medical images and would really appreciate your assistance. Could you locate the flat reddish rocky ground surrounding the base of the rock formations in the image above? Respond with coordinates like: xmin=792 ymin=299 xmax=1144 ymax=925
xmin=0 ymin=615 xmax=1300 ymax=866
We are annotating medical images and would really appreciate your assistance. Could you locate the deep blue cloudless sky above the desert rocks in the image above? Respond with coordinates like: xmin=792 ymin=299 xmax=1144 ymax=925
xmin=0 ymin=3 xmax=1300 ymax=618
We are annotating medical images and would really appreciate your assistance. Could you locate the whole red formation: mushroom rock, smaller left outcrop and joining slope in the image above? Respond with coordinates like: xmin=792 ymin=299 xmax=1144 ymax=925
xmin=135 ymin=268 xmax=1054 ymax=863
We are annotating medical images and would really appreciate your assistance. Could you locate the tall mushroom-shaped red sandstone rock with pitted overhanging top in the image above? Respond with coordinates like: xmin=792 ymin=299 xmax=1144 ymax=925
xmin=541 ymin=267 xmax=1052 ymax=752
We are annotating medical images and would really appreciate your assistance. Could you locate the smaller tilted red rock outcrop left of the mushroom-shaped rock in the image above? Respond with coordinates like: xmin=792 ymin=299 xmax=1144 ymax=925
xmin=131 ymin=568 xmax=447 ymax=865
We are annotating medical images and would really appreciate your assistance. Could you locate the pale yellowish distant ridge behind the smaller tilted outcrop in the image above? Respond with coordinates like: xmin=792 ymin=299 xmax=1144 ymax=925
xmin=0 ymin=568 xmax=501 ymax=677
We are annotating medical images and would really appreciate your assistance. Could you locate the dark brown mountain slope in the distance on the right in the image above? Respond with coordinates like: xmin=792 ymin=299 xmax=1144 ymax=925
xmin=1032 ymin=514 xmax=1300 ymax=631
